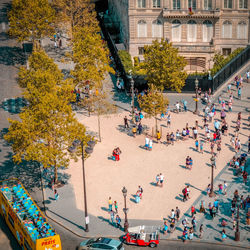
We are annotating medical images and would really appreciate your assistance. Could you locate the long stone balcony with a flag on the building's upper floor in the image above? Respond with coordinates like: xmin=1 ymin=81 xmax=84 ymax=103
xmin=163 ymin=8 xmax=221 ymax=18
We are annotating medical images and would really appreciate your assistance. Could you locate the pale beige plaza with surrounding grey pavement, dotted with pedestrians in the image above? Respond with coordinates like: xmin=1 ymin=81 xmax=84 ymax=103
xmin=39 ymin=44 xmax=249 ymax=245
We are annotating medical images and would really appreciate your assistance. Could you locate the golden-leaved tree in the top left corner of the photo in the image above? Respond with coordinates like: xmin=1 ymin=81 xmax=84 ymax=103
xmin=8 ymin=0 xmax=55 ymax=42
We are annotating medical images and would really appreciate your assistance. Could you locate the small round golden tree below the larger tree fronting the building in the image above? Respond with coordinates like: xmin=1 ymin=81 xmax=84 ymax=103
xmin=138 ymin=84 xmax=169 ymax=135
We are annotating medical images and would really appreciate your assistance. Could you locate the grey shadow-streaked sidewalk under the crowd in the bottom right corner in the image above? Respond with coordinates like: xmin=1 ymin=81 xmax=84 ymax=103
xmin=167 ymin=143 xmax=250 ymax=246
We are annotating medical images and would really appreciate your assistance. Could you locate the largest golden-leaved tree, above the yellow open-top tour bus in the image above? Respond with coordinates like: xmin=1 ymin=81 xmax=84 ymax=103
xmin=4 ymin=48 xmax=90 ymax=182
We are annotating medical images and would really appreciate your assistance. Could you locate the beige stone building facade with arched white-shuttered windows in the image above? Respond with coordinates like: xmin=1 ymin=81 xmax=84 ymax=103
xmin=109 ymin=0 xmax=250 ymax=72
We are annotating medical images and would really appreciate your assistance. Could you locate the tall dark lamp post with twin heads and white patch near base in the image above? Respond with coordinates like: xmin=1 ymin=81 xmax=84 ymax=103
xmin=69 ymin=140 xmax=95 ymax=232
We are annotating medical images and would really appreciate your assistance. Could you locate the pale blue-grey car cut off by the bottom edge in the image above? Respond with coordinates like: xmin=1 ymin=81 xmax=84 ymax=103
xmin=78 ymin=237 xmax=124 ymax=250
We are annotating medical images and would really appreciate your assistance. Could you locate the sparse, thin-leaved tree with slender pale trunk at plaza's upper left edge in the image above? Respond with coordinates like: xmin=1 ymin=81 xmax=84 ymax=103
xmin=81 ymin=88 xmax=116 ymax=142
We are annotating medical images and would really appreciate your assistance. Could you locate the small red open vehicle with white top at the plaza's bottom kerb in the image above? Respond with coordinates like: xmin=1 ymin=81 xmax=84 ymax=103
xmin=123 ymin=226 xmax=160 ymax=247
